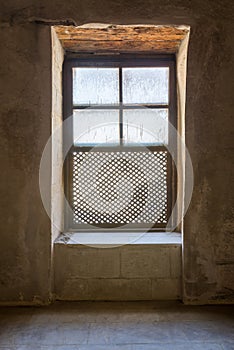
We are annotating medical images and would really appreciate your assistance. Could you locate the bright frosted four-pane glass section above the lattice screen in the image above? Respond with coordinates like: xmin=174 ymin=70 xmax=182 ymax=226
xmin=73 ymin=67 xmax=169 ymax=146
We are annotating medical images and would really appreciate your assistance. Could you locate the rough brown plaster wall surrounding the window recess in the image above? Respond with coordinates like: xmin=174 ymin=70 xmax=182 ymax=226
xmin=0 ymin=0 xmax=234 ymax=303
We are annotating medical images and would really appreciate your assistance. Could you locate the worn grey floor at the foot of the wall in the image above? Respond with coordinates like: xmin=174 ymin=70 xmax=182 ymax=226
xmin=0 ymin=302 xmax=234 ymax=350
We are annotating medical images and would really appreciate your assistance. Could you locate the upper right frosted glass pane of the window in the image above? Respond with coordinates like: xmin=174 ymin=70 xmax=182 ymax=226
xmin=123 ymin=67 xmax=169 ymax=104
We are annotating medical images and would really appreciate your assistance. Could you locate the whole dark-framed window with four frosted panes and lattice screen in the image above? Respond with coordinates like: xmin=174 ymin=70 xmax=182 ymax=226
xmin=64 ymin=55 xmax=177 ymax=231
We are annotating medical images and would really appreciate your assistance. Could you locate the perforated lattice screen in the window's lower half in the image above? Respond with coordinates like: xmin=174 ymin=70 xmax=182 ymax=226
xmin=72 ymin=151 xmax=168 ymax=227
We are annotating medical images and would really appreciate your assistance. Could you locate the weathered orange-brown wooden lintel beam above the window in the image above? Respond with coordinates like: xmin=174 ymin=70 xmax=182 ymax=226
xmin=55 ymin=26 xmax=188 ymax=52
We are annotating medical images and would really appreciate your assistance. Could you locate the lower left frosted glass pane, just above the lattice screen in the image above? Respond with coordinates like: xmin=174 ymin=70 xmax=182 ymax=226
xmin=73 ymin=109 xmax=119 ymax=146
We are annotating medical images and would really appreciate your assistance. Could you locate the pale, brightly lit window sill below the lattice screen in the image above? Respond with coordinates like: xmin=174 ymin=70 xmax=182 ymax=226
xmin=55 ymin=232 xmax=182 ymax=246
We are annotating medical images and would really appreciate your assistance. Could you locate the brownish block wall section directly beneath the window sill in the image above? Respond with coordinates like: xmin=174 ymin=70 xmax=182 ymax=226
xmin=54 ymin=242 xmax=182 ymax=300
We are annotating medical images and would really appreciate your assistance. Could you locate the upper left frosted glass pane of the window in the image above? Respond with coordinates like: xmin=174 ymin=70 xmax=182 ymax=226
xmin=73 ymin=68 xmax=119 ymax=105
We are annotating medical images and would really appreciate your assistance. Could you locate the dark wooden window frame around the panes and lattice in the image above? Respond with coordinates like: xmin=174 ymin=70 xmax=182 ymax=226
xmin=63 ymin=54 xmax=178 ymax=232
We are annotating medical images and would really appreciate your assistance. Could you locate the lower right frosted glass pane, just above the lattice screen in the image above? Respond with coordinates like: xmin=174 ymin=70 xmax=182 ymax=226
xmin=123 ymin=109 xmax=168 ymax=145
